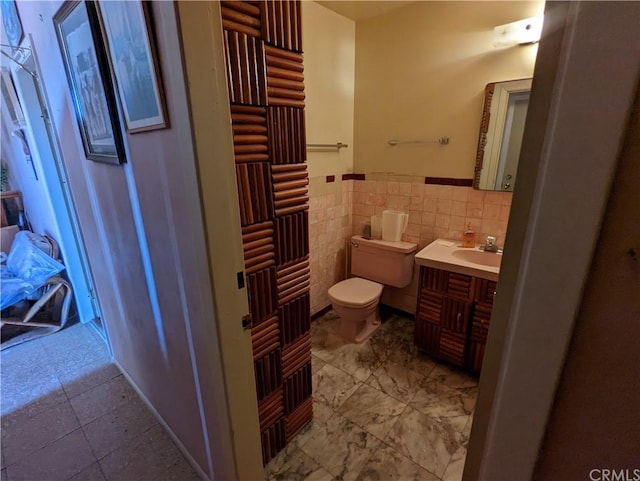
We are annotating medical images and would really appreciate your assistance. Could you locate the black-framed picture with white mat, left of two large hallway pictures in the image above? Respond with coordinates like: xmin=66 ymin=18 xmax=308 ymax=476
xmin=53 ymin=0 xmax=126 ymax=165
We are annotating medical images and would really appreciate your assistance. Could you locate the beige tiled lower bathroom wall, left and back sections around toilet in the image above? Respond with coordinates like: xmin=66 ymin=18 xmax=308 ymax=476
xmin=309 ymin=174 xmax=512 ymax=314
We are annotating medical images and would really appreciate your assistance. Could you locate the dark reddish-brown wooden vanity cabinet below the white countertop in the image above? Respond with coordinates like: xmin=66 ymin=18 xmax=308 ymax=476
xmin=415 ymin=267 xmax=496 ymax=372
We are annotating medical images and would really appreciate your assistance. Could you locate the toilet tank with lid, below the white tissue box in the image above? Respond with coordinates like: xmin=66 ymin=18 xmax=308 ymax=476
xmin=351 ymin=235 xmax=418 ymax=287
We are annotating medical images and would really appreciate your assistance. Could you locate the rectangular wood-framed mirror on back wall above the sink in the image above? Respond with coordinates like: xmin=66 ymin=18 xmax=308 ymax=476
xmin=473 ymin=78 xmax=531 ymax=192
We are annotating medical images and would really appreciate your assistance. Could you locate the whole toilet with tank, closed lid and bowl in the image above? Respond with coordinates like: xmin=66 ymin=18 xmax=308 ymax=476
xmin=328 ymin=236 xmax=418 ymax=343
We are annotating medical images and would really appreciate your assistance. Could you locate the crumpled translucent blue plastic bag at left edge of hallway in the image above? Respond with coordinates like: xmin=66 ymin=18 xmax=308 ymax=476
xmin=0 ymin=231 xmax=64 ymax=309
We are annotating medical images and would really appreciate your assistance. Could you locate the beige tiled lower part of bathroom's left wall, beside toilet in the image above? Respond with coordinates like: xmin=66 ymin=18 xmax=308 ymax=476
xmin=309 ymin=176 xmax=354 ymax=314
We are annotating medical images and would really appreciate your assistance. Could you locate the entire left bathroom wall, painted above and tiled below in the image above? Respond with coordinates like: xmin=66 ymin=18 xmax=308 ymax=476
xmin=302 ymin=2 xmax=356 ymax=314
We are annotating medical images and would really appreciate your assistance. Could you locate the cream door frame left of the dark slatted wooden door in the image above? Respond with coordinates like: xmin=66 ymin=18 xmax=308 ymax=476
xmin=175 ymin=1 xmax=264 ymax=479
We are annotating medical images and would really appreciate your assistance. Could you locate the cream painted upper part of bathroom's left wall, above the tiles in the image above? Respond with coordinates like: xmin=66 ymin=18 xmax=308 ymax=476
xmin=302 ymin=2 xmax=356 ymax=178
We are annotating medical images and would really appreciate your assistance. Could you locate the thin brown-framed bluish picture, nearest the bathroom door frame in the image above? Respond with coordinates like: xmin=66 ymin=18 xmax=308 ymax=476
xmin=100 ymin=0 xmax=168 ymax=134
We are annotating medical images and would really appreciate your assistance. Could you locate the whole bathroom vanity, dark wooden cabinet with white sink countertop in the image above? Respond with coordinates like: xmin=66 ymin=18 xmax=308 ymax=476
xmin=415 ymin=239 xmax=502 ymax=373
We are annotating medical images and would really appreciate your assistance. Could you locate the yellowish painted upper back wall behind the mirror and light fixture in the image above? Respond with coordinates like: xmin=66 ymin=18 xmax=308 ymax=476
xmin=354 ymin=1 xmax=544 ymax=178
